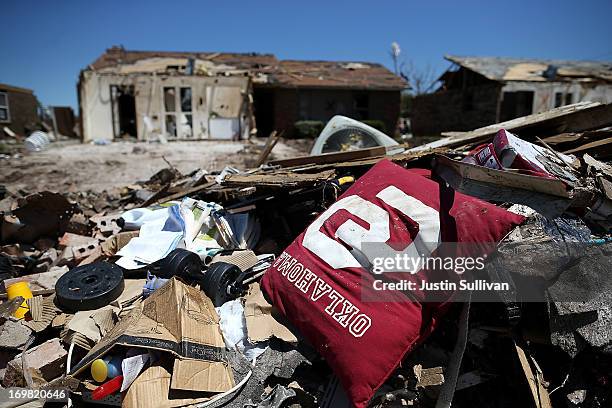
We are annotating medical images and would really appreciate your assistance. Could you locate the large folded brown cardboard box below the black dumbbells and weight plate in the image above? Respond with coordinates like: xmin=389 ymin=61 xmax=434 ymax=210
xmin=71 ymin=278 xmax=234 ymax=392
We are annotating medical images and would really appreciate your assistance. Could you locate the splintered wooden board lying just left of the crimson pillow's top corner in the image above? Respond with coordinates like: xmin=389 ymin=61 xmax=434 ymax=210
xmin=223 ymin=170 xmax=336 ymax=187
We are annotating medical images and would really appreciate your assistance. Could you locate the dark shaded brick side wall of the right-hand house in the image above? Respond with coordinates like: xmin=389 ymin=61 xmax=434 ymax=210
xmin=410 ymin=84 xmax=501 ymax=136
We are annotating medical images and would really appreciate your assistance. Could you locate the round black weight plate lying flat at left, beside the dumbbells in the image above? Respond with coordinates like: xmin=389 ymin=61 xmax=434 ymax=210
xmin=55 ymin=262 xmax=124 ymax=311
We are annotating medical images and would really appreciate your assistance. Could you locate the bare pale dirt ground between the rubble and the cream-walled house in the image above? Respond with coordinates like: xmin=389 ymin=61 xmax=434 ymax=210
xmin=0 ymin=139 xmax=312 ymax=192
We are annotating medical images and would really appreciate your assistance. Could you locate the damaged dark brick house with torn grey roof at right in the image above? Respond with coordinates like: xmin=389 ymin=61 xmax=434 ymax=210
xmin=411 ymin=55 xmax=612 ymax=135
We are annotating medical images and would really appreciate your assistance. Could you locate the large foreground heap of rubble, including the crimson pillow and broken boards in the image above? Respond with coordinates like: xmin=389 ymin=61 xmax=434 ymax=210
xmin=0 ymin=103 xmax=612 ymax=408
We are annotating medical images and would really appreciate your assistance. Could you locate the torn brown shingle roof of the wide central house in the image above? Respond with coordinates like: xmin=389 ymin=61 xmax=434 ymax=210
xmin=86 ymin=47 xmax=407 ymax=90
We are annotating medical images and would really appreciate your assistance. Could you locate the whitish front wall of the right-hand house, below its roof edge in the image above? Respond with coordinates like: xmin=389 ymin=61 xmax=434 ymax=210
xmin=502 ymin=81 xmax=612 ymax=113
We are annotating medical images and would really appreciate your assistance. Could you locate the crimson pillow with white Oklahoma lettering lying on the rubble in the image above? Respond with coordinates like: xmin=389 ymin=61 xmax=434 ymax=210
xmin=262 ymin=160 xmax=524 ymax=407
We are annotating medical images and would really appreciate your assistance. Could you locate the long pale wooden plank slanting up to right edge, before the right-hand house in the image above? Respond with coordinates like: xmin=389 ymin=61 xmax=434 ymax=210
xmin=408 ymin=102 xmax=612 ymax=152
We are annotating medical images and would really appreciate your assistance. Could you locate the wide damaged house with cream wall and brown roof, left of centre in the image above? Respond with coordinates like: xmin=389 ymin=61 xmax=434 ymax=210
xmin=78 ymin=47 xmax=406 ymax=142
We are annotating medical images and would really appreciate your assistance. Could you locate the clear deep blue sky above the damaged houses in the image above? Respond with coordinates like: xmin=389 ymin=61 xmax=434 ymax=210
xmin=0 ymin=0 xmax=612 ymax=109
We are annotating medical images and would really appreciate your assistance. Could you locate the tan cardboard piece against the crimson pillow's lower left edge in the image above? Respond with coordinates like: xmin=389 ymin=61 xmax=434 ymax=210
xmin=244 ymin=283 xmax=297 ymax=343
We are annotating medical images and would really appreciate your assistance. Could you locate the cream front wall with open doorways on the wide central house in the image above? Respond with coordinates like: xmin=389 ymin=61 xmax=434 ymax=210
xmin=79 ymin=71 xmax=251 ymax=142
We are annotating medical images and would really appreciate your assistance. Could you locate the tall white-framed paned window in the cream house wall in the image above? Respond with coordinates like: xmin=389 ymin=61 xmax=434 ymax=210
xmin=163 ymin=86 xmax=193 ymax=139
